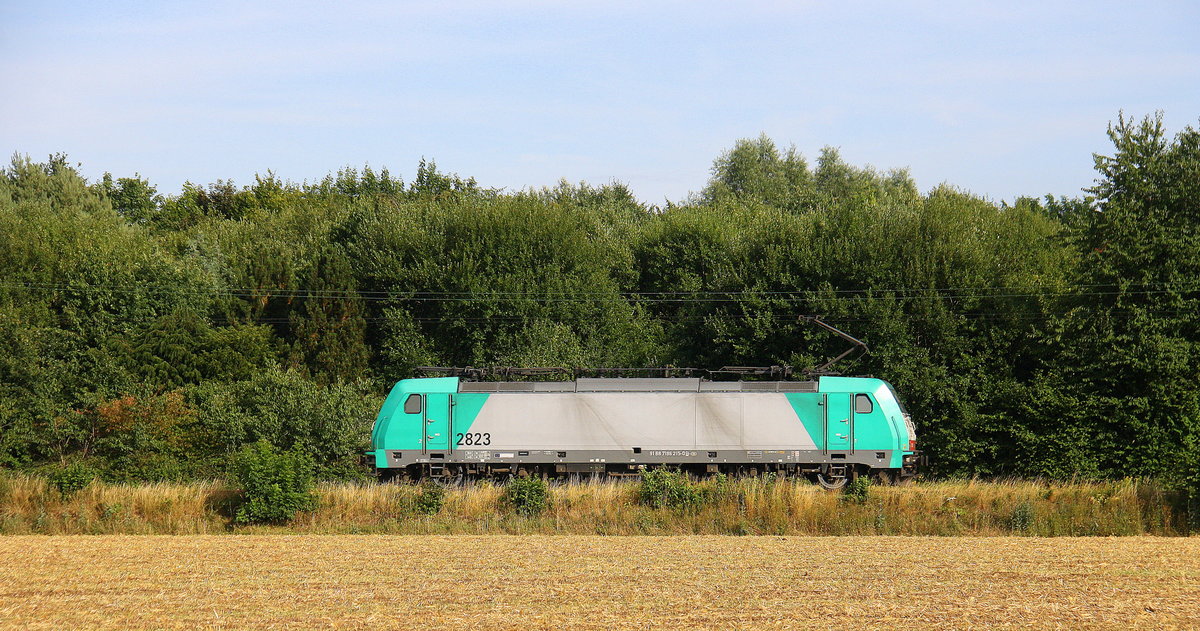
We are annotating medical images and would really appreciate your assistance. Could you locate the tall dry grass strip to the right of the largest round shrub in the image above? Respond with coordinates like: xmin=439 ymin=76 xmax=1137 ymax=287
xmin=292 ymin=480 xmax=1187 ymax=536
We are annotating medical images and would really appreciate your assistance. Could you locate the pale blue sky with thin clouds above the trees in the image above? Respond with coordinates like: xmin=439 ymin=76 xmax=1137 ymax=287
xmin=0 ymin=0 xmax=1200 ymax=203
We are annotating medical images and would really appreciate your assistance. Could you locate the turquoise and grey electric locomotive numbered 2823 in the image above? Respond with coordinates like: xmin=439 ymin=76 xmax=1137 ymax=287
xmin=370 ymin=375 xmax=918 ymax=488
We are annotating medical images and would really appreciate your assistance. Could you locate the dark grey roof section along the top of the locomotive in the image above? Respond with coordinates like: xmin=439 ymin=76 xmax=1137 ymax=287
xmin=458 ymin=377 xmax=817 ymax=392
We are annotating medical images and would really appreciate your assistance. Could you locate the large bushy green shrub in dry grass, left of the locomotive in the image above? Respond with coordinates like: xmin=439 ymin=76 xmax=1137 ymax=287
xmin=233 ymin=440 xmax=317 ymax=523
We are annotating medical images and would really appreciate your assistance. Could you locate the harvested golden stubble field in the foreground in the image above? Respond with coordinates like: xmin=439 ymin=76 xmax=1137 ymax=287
xmin=0 ymin=535 xmax=1200 ymax=630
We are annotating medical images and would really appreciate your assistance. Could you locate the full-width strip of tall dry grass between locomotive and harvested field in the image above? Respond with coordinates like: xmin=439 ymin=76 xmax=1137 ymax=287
xmin=0 ymin=476 xmax=1187 ymax=536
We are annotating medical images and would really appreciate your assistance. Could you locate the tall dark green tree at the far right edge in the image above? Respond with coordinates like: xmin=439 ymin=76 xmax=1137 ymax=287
xmin=1027 ymin=114 xmax=1200 ymax=476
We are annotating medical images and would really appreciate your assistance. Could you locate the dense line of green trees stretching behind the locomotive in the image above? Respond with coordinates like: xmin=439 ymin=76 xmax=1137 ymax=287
xmin=0 ymin=116 xmax=1200 ymax=481
